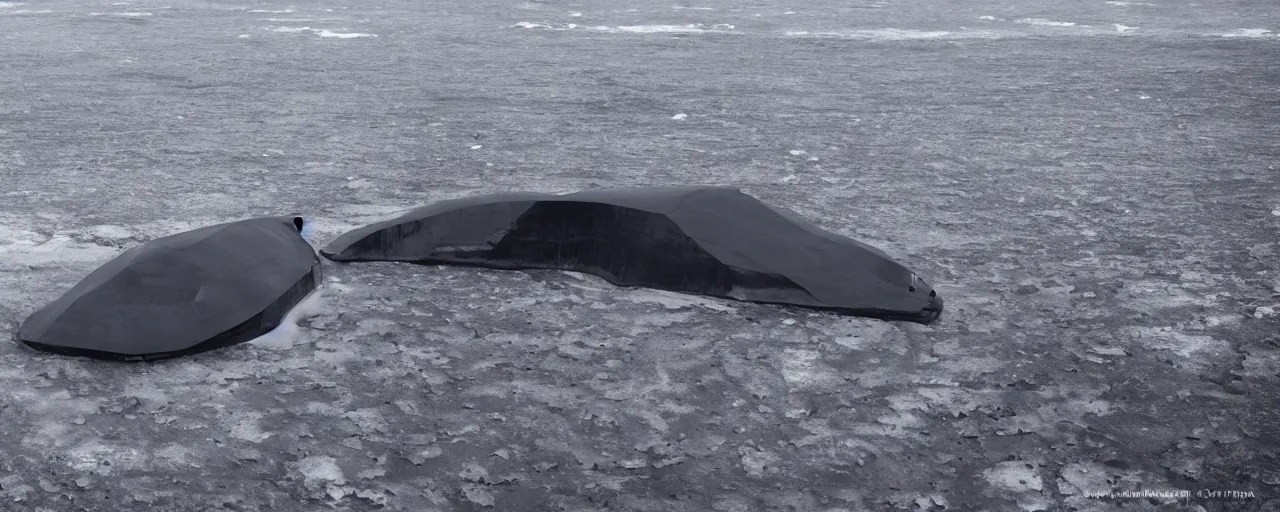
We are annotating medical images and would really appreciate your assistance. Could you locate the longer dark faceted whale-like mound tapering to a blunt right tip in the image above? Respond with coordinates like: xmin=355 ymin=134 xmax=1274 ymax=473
xmin=320 ymin=187 xmax=942 ymax=324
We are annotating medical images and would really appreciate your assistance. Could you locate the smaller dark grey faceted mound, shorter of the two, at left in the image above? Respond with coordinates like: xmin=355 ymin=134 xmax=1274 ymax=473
xmin=18 ymin=216 xmax=321 ymax=361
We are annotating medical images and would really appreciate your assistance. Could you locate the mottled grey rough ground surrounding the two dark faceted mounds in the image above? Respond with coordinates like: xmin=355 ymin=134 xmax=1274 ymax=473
xmin=0 ymin=0 xmax=1280 ymax=512
